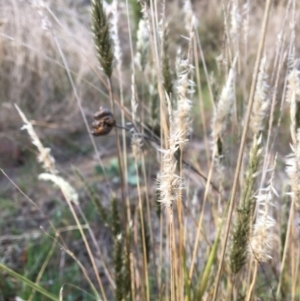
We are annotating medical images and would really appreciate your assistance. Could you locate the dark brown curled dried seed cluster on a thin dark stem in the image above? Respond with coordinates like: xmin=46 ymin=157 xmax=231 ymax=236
xmin=92 ymin=107 xmax=116 ymax=136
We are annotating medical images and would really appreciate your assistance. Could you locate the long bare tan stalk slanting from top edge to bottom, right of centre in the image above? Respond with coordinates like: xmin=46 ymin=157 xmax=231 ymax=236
xmin=212 ymin=0 xmax=272 ymax=301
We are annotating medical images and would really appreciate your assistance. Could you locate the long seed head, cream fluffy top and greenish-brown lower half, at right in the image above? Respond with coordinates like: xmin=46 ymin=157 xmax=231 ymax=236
xmin=230 ymin=58 xmax=270 ymax=274
